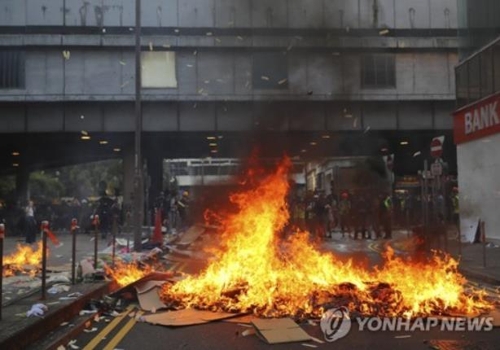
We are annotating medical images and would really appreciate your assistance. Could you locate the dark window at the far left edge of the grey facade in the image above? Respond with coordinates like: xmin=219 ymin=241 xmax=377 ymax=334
xmin=0 ymin=50 xmax=25 ymax=89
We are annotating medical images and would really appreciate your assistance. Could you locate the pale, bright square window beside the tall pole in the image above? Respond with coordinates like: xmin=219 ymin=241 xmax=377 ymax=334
xmin=141 ymin=51 xmax=177 ymax=88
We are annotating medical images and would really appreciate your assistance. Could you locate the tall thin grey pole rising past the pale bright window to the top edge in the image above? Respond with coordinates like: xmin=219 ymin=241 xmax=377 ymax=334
xmin=134 ymin=0 xmax=144 ymax=251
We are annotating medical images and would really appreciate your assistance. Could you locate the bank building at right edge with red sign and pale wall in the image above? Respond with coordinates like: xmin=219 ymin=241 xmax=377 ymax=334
xmin=454 ymin=1 xmax=500 ymax=241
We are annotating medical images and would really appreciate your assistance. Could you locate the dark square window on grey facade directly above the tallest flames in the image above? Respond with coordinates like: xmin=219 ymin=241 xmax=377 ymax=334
xmin=252 ymin=53 xmax=288 ymax=90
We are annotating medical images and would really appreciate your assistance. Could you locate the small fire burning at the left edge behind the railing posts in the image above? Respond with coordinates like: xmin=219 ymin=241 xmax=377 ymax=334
xmin=3 ymin=242 xmax=42 ymax=277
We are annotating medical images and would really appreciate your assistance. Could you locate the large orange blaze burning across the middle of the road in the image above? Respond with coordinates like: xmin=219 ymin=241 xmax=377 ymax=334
xmin=162 ymin=161 xmax=490 ymax=317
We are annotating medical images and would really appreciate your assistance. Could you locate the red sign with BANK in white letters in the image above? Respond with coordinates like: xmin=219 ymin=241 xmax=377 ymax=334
xmin=453 ymin=93 xmax=500 ymax=144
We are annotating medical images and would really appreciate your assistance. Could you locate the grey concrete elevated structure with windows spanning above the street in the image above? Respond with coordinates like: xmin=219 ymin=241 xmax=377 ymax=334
xmin=0 ymin=0 xmax=458 ymax=201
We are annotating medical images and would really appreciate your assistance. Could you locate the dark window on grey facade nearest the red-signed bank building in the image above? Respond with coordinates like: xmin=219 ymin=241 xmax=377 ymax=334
xmin=361 ymin=55 xmax=396 ymax=89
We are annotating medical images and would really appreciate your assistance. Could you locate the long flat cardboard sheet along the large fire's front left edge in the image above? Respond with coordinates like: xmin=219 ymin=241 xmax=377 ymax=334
xmin=143 ymin=309 xmax=238 ymax=327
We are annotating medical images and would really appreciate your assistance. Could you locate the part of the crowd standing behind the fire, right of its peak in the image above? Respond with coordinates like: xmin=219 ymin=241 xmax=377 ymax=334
xmin=289 ymin=187 xmax=459 ymax=239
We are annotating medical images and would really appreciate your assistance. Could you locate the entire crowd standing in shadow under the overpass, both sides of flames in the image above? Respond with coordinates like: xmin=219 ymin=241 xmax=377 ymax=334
xmin=0 ymin=187 xmax=459 ymax=243
